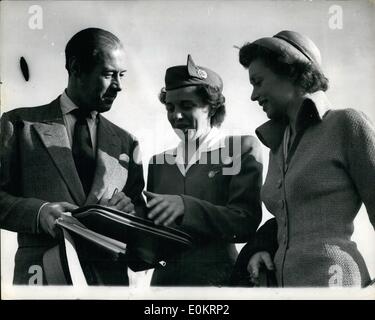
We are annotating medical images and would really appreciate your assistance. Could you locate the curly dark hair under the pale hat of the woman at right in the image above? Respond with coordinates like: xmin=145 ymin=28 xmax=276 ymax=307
xmin=239 ymin=43 xmax=329 ymax=93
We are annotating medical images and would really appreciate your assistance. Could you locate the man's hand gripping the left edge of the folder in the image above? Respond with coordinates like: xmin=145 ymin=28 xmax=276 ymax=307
xmin=39 ymin=202 xmax=79 ymax=238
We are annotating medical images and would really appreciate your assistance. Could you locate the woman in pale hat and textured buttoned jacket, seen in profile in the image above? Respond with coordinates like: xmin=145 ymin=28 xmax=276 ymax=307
xmin=239 ymin=31 xmax=375 ymax=287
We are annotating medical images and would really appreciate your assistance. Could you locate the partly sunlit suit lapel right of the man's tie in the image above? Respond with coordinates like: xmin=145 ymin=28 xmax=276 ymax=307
xmin=86 ymin=115 xmax=121 ymax=204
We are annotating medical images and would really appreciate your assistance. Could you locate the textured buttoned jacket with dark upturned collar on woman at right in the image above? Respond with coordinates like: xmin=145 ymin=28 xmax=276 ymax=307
xmin=256 ymin=92 xmax=375 ymax=287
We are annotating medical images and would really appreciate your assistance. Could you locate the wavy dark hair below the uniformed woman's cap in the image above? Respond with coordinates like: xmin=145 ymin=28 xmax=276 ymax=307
xmin=159 ymin=85 xmax=226 ymax=127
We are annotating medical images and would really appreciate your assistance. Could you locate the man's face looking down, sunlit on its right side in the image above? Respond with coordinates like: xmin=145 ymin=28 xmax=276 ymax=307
xmin=74 ymin=47 xmax=126 ymax=112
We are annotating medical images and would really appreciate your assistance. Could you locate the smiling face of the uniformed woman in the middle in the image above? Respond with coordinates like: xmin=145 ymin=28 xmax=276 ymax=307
xmin=165 ymin=86 xmax=211 ymax=140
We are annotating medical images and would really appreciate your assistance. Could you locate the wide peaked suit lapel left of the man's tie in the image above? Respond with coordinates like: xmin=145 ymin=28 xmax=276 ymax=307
xmin=33 ymin=99 xmax=85 ymax=205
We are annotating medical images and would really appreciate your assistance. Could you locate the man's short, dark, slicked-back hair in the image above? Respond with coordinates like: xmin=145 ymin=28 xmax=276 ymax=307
xmin=65 ymin=28 xmax=122 ymax=75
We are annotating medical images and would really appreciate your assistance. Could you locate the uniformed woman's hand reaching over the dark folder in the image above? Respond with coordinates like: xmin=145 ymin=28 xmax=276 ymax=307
xmin=143 ymin=191 xmax=185 ymax=226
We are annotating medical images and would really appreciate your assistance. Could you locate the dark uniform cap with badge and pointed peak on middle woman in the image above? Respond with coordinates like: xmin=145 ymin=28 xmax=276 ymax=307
xmin=165 ymin=54 xmax=223 ymax=91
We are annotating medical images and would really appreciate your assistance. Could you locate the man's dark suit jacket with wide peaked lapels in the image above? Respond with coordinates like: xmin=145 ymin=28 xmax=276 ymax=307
xmin=0 ymin=98 xmax=144 ymax=284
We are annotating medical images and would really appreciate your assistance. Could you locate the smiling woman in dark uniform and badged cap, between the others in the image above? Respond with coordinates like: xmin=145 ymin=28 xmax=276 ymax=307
xmin=145 ymin=55 xmax=262 ymax=286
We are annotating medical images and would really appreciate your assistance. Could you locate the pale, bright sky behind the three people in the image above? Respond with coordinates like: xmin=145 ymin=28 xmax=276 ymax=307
xmin=0 ymin=1 xmax=375 ymax=298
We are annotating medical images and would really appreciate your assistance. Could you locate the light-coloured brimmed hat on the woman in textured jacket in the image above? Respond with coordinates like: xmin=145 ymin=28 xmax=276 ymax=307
xmin=253 ymin=30 xmax=322 ymax=66
